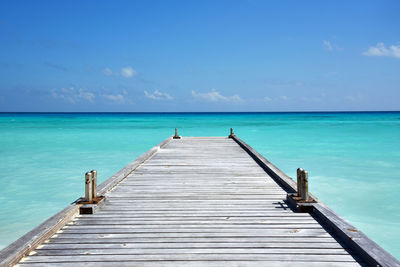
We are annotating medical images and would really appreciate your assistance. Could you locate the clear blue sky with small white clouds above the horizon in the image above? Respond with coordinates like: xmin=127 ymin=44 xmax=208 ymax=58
xmin=0 ymin=0 xmax=400 ymax=112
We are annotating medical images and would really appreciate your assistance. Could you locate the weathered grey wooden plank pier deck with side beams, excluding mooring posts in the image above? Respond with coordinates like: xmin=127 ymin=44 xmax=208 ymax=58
xmin=0 ymin=132 xmax=400 ymax=266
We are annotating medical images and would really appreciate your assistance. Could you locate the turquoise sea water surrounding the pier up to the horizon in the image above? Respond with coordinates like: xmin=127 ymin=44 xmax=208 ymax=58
xmin=0 ymin=112 xmax=400 ymax=258
